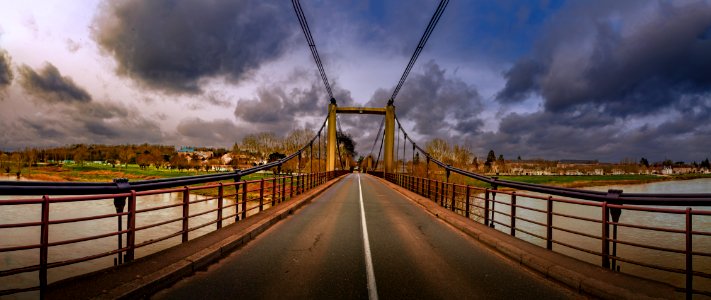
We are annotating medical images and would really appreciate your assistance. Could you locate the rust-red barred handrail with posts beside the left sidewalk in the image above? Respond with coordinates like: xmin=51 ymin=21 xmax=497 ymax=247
xmin=0 ymin=169 xmax=346 ymax=296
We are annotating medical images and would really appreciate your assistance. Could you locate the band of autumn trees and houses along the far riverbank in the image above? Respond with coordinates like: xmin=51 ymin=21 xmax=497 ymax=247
xmin=0 ymin=135 xmax=711 ymax=176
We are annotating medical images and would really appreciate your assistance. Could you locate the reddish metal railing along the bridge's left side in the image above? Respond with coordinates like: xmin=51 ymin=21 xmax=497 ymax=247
xmin=0 ymin=171 xmax=345 ymax=296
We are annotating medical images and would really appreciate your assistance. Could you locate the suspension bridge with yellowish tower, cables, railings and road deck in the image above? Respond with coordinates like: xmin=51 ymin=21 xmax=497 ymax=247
xmin=0 ymin=0 xmax=711 ymax=299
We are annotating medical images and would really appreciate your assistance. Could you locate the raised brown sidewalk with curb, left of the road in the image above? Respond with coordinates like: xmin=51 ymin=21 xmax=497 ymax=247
xmin=46 ymin=175 xmax=347 ymax=299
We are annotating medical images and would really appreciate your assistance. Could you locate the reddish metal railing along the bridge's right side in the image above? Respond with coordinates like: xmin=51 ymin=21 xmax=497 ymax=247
xmin=385 ymin=173 xmax=711 ymax=297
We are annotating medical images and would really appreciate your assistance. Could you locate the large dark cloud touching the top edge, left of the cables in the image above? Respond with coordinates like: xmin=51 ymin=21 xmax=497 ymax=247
xmin=93 ymin=0 xmax=298 ymax=93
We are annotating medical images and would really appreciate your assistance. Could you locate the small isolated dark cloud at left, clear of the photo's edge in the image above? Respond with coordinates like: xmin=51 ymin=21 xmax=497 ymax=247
xmin=17 ymin=63 xmax=91 ymax=103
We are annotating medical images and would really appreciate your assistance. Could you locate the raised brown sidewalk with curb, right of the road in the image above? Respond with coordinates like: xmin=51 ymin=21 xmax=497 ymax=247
xmin=378 ymin=178 xmax=684 ymax=299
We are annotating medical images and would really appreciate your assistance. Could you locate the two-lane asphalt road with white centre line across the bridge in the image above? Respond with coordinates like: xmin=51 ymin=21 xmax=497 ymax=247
xmin=154 ymin=174 xmax=575 ymax=299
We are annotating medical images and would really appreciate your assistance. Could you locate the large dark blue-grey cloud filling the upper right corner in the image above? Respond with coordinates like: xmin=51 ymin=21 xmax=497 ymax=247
xmin=497 ymin=1 xmax=711 ymax=116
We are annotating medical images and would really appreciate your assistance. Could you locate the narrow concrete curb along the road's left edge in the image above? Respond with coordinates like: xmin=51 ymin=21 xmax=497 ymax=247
xmin=87 ymin=175 xmax=346 ymax=299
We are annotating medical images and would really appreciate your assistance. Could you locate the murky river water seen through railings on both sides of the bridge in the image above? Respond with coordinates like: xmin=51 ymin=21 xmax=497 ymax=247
xmin=0 ymin=176 xmax=711 ymax=298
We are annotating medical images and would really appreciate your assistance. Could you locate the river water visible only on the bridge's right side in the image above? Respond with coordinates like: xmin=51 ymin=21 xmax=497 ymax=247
xmin=484 ymin=178 xmax=711 ymax=291
